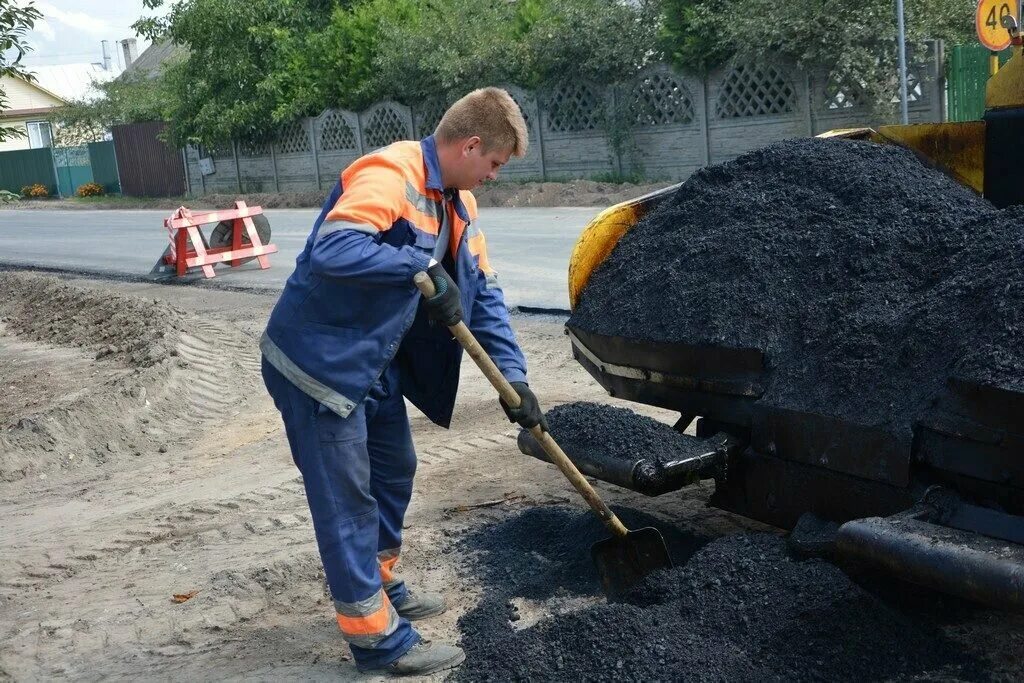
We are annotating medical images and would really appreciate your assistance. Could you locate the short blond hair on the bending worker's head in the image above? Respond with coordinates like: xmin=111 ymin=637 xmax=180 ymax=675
xmin=434 ymin=88 xmax=528 ymax=157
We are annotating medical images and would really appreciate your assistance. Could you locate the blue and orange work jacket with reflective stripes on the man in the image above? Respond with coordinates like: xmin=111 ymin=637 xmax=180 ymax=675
xmin=260 ymin=136 xmax=526 ymax=427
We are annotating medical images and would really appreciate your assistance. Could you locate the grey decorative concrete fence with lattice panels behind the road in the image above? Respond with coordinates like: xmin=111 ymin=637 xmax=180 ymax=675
xmin=182 ymin=46 xmax=944 ymax=194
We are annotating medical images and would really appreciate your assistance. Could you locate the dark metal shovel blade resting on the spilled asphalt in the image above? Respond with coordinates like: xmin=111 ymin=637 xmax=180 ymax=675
xmin=590 ymin=526 xmax=672 ymax=600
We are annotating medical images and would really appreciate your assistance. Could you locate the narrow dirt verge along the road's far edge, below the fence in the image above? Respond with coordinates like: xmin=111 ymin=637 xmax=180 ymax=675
xmin=0 ymin=180 xmax=672 ymax=210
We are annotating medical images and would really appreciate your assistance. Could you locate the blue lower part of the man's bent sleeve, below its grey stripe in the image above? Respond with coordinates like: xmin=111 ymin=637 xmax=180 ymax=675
xmin=309 ymin=229 xmax=430 ymax=287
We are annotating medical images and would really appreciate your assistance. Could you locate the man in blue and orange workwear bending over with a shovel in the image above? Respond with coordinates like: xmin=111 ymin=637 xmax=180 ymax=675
xmin=260 ymin=88 xmax=543 ymax=674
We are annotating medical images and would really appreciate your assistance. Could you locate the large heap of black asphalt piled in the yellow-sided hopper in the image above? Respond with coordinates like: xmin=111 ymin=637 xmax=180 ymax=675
xmin=569 ymin=139 xmax=1024 ymax=438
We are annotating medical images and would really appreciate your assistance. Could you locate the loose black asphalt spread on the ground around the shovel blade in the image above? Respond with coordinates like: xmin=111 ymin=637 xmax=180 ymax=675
xmin=455 ymin=508 xmax=984 ymax=681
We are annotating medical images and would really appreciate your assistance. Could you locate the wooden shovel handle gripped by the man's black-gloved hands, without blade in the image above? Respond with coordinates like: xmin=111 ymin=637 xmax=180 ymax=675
xmin=413 ymin=272 xmax=629 ymax=537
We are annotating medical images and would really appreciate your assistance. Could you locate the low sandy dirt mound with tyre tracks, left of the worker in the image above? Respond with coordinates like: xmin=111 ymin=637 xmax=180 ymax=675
xmin=0 ymin=272 xmax=259 ymax=481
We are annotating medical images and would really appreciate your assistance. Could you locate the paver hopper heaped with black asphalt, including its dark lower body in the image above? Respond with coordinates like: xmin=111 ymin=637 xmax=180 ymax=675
xmin=565 ymin=139 xmax=1024 ymax=528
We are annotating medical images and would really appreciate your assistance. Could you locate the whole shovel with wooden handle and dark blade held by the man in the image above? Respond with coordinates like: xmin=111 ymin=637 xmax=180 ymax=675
xmin=413 ymin=272 xmax=672 ymax=600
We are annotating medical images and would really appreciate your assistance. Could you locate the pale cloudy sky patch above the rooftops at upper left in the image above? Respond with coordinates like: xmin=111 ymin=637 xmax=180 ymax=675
xmin=20 ymin=0 xmax=167 ymax=67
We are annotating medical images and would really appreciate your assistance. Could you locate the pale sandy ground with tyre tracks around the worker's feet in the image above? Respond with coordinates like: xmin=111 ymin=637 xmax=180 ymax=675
xmin=0 ymin=273 xmax=756 ymax=681
